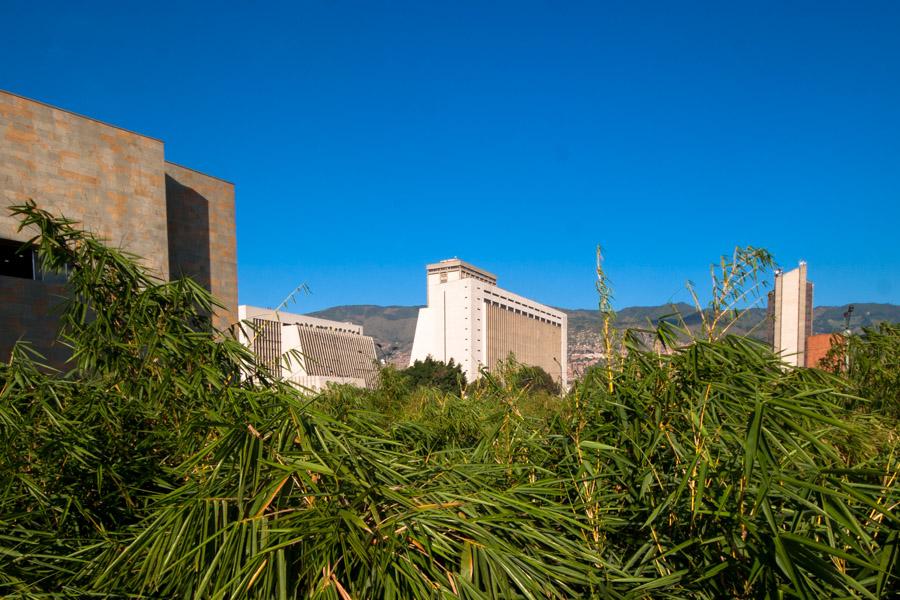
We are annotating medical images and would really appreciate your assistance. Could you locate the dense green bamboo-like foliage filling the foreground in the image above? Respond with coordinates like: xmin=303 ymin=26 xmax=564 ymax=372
xmin=0 ymin=205 xmax=900 ymax=600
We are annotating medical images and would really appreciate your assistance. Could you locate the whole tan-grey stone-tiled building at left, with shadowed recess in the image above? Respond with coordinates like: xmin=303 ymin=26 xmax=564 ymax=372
xmin=0 ymin=91 xmax=237 ymax=364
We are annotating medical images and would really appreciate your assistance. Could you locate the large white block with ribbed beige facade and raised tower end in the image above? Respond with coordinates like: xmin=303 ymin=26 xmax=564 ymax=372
xmin=410 ymin=258 xmax=568 ymax=389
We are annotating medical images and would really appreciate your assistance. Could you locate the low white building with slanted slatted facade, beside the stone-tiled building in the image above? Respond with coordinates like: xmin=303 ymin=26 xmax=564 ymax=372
xmin=238 ymin=305 xmax=378 ymax=390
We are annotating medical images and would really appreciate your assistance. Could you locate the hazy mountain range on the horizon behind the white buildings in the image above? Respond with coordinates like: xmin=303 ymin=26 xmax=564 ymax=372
xmin=310 ymin=303 xmax=900 ymax=367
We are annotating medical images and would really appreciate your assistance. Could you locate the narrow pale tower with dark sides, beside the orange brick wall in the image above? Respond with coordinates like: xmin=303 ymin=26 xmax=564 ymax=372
xmin=767 ymin=261 xmax=813 ymax=367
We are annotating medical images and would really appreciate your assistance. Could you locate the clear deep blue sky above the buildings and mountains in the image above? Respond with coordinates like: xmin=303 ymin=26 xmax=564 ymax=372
xmin=0 ymin=0 xmax=900 ymax=312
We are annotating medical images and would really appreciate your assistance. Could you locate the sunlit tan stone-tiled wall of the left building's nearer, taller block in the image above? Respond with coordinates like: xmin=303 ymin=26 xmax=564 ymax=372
xmin=0 ymin=92 xmax=169 ymax=278
